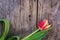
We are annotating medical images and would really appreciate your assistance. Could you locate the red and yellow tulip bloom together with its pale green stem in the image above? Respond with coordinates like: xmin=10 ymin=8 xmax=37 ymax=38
xmin=23 ymin=19 xmax=51 ymax=40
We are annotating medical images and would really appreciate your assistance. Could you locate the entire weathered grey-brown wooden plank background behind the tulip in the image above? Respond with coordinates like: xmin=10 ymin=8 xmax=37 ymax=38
xmin=0 ymin=0 xmax=60 ymax=40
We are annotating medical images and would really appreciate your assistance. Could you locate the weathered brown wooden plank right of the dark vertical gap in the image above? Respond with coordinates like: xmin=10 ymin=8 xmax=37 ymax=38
xmin=38 ymin=0 xmax=60 ymax=40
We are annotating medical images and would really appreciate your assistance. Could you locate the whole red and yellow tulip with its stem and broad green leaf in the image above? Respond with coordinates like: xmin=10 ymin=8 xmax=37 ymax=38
xmin=22 ymin=19 xmax=51 ymax=40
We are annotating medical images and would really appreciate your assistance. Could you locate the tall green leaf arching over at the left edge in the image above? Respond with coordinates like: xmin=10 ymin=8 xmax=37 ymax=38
xmin=0 ymin=19 xmax=10 ymax=40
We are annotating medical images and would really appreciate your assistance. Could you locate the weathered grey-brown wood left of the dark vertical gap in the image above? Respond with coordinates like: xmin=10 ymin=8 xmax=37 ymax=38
xmin=0 ymin=0 xmax=37 ymax=37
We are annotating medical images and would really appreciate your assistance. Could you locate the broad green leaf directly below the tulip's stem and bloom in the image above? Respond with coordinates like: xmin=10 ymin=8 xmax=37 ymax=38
xmin=23 ymin=30 xmax=48 ymax=40
